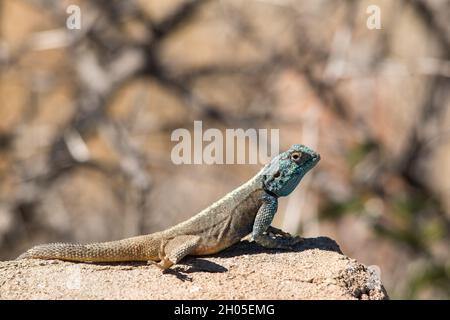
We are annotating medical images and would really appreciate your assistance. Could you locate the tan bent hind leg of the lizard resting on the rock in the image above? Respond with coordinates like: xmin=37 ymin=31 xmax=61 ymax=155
xmin=153 ymin=235 xmax=200 ymax=270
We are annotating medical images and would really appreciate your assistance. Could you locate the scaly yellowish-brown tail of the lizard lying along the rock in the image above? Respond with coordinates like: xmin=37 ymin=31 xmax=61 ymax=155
xmin=17 ymin=236 xmax=159 ymax=262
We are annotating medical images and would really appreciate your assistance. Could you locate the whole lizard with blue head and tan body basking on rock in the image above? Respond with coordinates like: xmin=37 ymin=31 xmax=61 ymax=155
xmin=17 ymin=144 xmax=320 ymax=270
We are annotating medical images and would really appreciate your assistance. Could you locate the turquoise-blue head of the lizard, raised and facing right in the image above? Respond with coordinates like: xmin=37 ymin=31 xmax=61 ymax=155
xmin=262 ymin=144 xmax=320 ymax=197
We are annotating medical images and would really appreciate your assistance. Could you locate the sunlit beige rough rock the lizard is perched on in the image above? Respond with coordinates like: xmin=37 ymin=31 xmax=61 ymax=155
xmin=0 ymin=237 xmax=388 ymax=299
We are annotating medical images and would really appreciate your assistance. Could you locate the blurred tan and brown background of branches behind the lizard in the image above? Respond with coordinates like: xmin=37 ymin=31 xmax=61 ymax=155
xmin=0 ymin=0 xmax=450 ymax=299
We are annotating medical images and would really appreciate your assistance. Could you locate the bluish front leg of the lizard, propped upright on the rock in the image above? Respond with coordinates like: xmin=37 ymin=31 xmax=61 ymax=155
xmin=252 ymin=193 xmax=301 ymax=249
